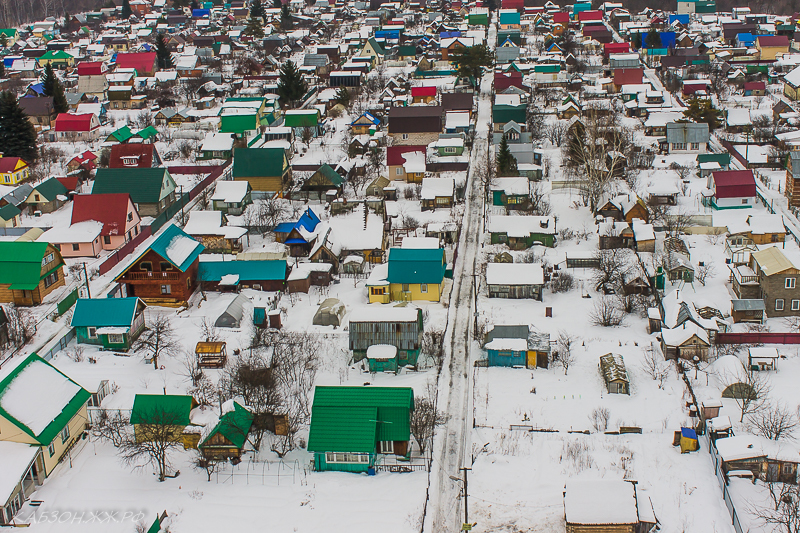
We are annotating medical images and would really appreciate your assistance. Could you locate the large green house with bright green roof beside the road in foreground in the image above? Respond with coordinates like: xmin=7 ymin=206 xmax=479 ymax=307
xmin=308 ymin=386 xmax=414 ymax=472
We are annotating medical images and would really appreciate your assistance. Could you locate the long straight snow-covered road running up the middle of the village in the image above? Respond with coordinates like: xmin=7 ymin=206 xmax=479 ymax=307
xmin=423 ymin=24 xmax=497 ymax=533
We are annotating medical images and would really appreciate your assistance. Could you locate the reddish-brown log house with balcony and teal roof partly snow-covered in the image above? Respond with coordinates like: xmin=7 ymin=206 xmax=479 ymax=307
xmin=114 ymin=224 xmax=204 ymax=305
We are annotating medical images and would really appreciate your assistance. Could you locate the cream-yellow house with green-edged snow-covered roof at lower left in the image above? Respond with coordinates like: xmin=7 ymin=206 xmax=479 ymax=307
xmin=0 ymin=354 xmax=91 ymax=476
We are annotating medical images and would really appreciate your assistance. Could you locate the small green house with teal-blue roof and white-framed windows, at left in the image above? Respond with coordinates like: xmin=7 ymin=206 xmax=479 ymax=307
xmin=71 ymin=297 xmax=147 ymax=351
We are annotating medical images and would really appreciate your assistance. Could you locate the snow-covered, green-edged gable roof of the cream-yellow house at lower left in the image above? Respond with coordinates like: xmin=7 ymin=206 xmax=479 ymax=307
xmin=0 ymin=353 xmax=91 ymax=446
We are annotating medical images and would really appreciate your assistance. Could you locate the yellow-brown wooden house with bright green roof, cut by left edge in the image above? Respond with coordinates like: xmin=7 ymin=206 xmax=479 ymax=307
xmin=0 ymin=241 xmax=65 ymax=307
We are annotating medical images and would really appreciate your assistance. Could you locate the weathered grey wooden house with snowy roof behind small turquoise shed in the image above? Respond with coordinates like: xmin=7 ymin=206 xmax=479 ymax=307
xmin=348 ymin=304 xmax=423 ymax=366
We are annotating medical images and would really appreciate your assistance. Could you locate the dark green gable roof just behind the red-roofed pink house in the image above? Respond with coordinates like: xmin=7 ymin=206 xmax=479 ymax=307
xmin=92 ymin=168 xmax=175 ymax=204
